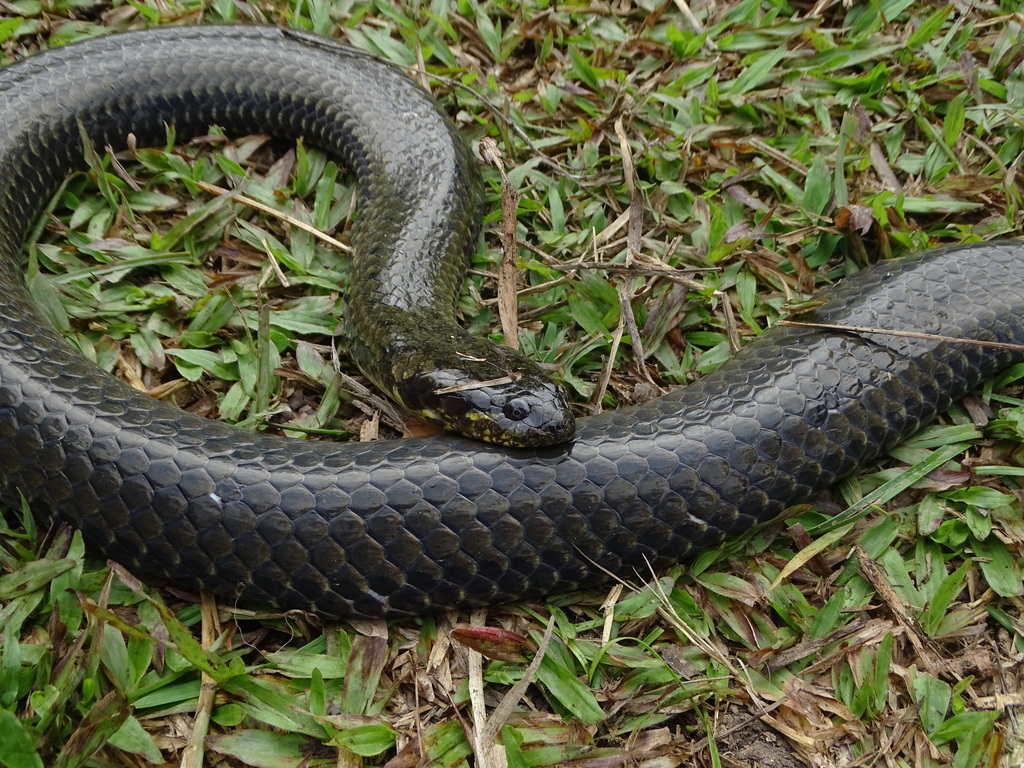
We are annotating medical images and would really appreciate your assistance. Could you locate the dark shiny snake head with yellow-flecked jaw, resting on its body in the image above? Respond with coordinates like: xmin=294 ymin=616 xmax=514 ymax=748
xmin=396 ymin=344 xmax=575 ymax=447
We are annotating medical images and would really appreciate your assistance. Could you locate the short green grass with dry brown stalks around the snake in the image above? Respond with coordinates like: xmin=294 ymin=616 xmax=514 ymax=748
xmin=0 ymin=0 xmax=1024 ymax=768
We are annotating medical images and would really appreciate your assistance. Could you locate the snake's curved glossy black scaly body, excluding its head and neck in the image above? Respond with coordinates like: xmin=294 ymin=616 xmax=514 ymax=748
xmin=0 ymin=26 xmax=1024 ymax=620
